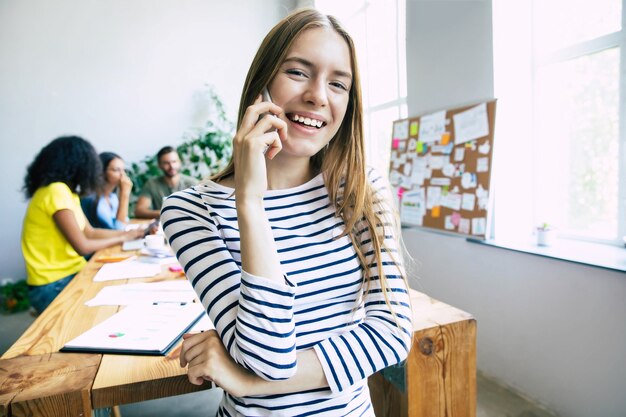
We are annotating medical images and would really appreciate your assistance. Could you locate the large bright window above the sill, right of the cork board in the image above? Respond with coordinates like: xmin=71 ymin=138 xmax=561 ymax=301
xmin=493 ymin=0 xmax=626 ymax=243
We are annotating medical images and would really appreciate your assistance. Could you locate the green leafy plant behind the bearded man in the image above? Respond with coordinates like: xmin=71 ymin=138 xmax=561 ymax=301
xmin=128 ymin=86 xmax=234 ymax=213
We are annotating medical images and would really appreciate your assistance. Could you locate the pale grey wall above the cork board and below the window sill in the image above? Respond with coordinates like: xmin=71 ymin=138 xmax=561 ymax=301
xmin=404 ymin=0 xmax=626 ymax=417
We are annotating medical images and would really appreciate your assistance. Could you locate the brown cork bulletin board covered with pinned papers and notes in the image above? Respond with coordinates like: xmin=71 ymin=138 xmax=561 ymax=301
xmin=389 ymin=100 xmax=496 ymax=238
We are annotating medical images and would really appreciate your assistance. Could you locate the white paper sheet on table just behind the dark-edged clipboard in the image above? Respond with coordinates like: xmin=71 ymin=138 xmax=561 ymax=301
xmin=85 ymin=280 xmax=196 ymax=307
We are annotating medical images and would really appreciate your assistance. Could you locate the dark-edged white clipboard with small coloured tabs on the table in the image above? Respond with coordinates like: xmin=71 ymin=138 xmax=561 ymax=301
xmin=60 ymin=303 xmax=206 ymax=355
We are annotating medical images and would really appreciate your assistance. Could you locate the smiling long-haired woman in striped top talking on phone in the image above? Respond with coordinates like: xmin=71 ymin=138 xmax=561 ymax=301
xmin=161 ymin=6 xmax=412 ymax=416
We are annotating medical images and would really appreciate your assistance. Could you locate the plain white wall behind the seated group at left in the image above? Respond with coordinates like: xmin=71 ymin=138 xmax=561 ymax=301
xmin=0 ymin=0 xmax=295 ymax=281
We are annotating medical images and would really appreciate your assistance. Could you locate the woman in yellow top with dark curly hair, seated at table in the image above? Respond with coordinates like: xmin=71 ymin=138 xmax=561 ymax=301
xmin=22 ymin=136 xmax=143 ymax=313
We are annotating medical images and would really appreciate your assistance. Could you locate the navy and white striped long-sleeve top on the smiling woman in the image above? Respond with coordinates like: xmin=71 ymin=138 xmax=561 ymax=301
xmin=161 ymin=167 xmax=412 ymax=416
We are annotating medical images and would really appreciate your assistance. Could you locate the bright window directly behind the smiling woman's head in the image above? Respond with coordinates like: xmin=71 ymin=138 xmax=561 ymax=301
xmin=315 ymin=0 xmax=407 ymax=173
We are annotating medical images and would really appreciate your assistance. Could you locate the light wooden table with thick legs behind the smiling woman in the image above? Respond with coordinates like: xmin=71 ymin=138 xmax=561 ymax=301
xmin=0 ymin=246 xmax=476 ymax=417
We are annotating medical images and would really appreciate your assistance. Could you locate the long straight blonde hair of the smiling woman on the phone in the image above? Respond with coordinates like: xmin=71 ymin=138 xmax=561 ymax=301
xmin=211 ymin=9 xmax=399 ymax=316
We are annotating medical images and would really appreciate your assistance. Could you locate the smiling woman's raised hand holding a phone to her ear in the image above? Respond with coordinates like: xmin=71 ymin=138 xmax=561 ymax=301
xmin=233 ymin=89 xmax=287 ymax=201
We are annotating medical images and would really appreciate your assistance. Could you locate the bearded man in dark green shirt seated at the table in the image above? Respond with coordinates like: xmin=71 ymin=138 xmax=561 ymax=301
xmin=135 ymin=146 xmax=198 ymax=219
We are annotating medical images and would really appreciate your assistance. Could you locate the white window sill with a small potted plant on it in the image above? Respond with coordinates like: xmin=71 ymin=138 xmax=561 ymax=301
xmin=467 ymin=237 xmax=626 ymax=272
